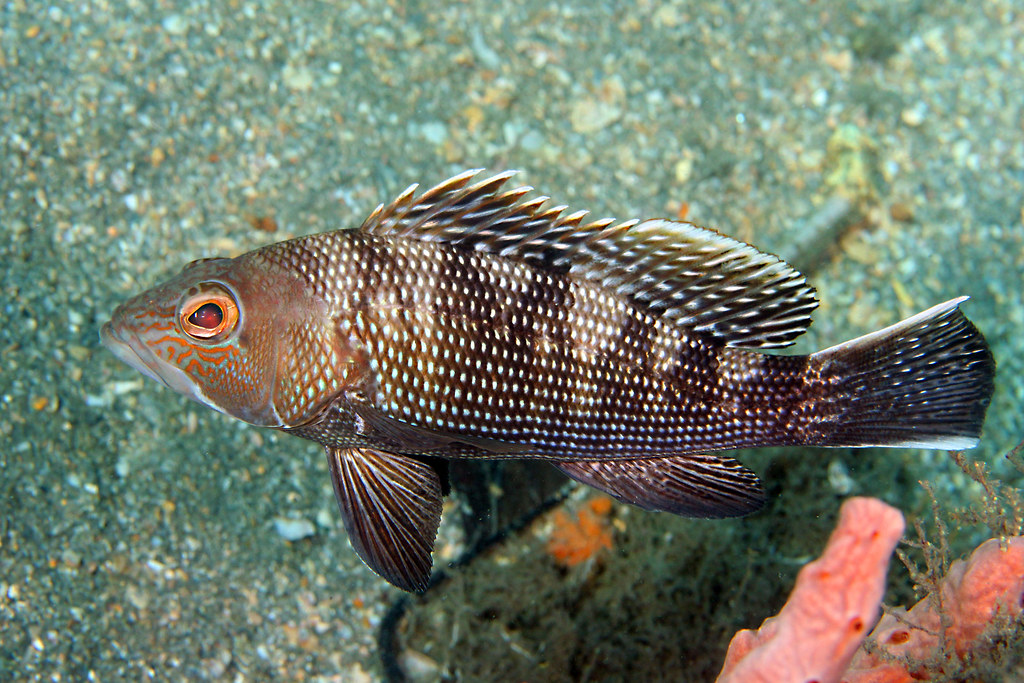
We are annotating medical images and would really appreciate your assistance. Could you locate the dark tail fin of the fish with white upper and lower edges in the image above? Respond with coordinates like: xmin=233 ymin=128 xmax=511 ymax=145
xmin=809 ymin=297 xmax=995 ymax=451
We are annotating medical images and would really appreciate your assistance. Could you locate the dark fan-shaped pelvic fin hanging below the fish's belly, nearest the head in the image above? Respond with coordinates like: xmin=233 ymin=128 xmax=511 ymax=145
xmin=327 ymin=447 xmax=441 ymax=592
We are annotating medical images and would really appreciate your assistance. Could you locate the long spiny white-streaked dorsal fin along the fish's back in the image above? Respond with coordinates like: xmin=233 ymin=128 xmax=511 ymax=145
xmin=359 ymin=170 xmax=817 ymax=348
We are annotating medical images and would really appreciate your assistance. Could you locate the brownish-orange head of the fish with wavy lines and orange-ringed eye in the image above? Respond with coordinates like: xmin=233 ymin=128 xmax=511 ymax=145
xmin=100 ymin=256 xmax=302 ymax=427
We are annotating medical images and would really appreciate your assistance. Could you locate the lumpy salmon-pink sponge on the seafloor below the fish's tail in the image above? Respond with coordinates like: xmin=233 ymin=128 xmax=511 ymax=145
xmin=718 ymin=498 xmax=1024 ymax=683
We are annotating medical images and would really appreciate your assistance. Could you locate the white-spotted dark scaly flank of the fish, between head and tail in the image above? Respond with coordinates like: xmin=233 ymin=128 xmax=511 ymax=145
xmin=259 ymin=232 xmax=813 ymax=460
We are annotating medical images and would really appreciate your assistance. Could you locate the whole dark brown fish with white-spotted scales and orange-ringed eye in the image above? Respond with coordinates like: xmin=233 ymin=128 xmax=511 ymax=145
xmin=100 ymin=170 xmax=995 ymax=592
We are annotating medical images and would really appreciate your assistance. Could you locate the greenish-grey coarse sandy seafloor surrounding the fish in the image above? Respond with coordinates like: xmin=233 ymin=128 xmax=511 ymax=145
xmin=0 ymin=0 xmax=1024 ymax=681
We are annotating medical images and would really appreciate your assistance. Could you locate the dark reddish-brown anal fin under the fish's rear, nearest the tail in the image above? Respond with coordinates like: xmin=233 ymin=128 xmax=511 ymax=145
xmin=555 ymin=455 xmax=765 ymax=518
